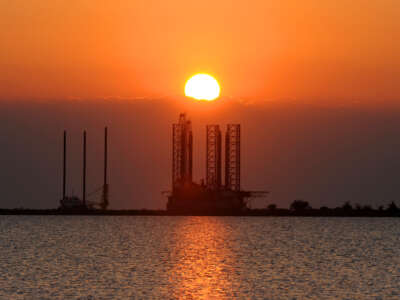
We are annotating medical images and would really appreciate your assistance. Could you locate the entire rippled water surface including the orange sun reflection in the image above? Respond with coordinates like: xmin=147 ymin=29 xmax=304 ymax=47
xmin=0 ymin=216 xmax=400 ymax=299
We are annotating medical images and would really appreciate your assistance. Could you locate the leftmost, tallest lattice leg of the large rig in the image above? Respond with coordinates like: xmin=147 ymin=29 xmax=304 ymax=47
xmin=172 ymin=114 xmax=193 ymax=188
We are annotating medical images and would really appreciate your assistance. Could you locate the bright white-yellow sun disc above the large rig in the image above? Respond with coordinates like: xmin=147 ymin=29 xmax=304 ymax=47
xmin=185 ymin=74 xmax=221 ymax=101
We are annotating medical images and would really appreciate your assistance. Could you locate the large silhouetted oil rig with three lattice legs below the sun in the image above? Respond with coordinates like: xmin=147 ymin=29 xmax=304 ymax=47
xmin=167 ymin=114 xmax=268 ymax=214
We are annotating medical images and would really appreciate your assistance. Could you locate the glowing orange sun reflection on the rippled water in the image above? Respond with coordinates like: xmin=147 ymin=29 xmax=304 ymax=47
xmin=169 ymin=217 xmax=239 ymax=299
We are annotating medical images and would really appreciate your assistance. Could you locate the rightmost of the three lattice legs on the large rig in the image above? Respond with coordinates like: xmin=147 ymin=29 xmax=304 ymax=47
xmin=225 ymin=124 xmax=240 ymax=191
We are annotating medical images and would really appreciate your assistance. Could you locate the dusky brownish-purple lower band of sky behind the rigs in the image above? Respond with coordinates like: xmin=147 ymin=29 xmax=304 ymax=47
xmin=0 ymin=98 xmax=400 ymax=208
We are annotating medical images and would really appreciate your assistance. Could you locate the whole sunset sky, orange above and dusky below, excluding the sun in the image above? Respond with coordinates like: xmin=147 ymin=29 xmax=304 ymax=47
xmin=0 ymin=0 xmax=400 ymax=208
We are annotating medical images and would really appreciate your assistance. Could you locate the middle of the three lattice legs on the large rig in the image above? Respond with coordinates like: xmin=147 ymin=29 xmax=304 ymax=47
xmin=206 ymin=125 xmax=221 ymax=189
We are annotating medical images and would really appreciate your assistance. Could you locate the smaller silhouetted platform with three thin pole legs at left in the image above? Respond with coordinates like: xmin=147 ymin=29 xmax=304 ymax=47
xmin=59 ymin=127 xmax=109 ymax=213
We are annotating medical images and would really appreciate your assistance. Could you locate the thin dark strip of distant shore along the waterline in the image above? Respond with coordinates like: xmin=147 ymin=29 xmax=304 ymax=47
xmin=0 ymin=208 xmax=400 ymax=217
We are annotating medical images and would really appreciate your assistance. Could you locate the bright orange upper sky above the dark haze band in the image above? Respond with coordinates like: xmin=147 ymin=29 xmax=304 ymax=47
xmin=0 ymin=0 xmax=400 ymax=103
